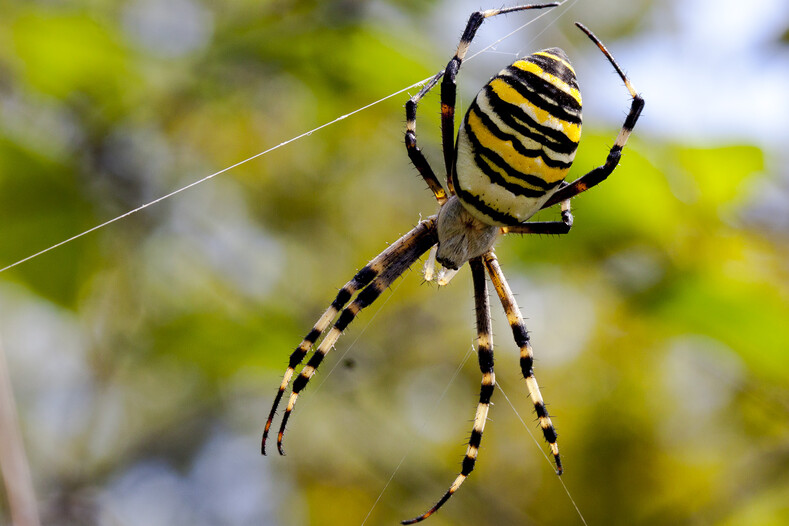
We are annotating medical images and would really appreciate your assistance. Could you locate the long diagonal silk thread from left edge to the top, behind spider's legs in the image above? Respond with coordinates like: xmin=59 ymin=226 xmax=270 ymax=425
xmin=0 ymin=0 xmax=578 ymax=273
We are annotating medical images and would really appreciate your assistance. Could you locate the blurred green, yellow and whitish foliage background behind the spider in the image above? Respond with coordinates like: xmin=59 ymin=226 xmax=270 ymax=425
xmin=0 ymin=0 xmax=789 ymax=526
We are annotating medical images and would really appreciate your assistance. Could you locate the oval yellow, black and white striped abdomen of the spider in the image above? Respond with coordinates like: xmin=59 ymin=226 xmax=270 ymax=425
xmin=452 ymin=48 xmax=581 ymax=226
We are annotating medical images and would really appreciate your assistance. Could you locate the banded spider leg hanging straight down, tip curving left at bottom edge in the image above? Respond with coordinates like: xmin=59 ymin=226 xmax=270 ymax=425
xmin=402 ymin=257 xmax=496 ymax=524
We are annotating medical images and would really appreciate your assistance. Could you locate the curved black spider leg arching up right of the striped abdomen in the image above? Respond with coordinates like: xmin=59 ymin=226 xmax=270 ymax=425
xmin=542 ymin=22 xmax=644 ymax=208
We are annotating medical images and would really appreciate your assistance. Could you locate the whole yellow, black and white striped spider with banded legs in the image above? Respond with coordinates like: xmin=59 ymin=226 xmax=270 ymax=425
xmin=261 ymin=3 xmax=644 ymax=524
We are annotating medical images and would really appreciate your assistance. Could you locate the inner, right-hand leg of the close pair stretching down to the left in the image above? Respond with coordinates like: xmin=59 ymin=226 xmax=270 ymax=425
xmin=274 ymin=216 xmax=437 ymax=455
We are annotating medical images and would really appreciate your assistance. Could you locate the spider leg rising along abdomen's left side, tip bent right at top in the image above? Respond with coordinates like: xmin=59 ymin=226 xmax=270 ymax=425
xmin=441 ymin=2 xmax=559 ymax=184
